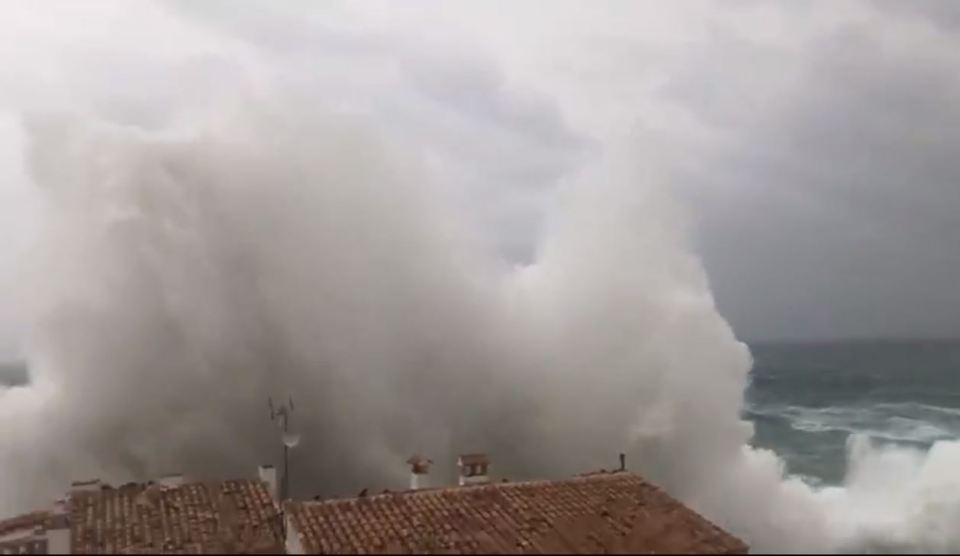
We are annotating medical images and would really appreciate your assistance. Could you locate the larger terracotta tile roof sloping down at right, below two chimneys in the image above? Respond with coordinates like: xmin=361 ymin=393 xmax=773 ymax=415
xmin=286 ymin=472 xmax=747 ymax=554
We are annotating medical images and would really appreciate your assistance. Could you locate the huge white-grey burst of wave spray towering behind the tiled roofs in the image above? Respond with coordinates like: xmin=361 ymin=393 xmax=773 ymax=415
xmin=0 ymin=5 xmax=960 ymax=551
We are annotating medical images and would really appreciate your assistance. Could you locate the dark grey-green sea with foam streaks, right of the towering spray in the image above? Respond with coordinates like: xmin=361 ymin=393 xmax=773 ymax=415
xmin=743 ymin=340 xmax=960 ymax=484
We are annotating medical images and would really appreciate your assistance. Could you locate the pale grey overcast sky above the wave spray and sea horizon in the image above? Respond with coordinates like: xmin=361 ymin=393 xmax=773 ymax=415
xmin=0 ymin=0 xmax=960 ymax=353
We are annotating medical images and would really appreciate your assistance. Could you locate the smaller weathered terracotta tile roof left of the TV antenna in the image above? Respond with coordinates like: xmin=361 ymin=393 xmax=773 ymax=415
xmin=70 ymin=480 xmax=283 ymax=554
